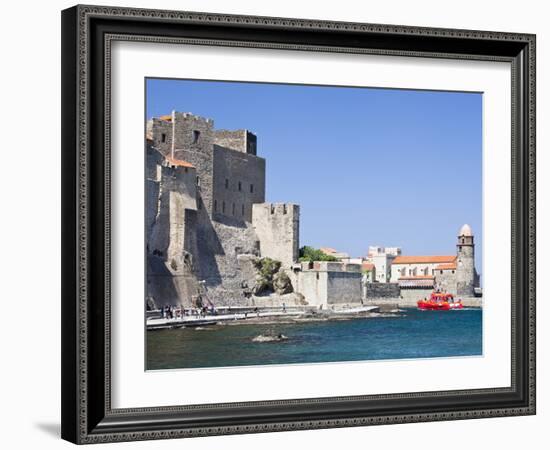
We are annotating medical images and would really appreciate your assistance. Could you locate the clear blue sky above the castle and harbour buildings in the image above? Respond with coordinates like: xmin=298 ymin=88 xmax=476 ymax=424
xmin=146 ymin=79 xmax=482 ymax=272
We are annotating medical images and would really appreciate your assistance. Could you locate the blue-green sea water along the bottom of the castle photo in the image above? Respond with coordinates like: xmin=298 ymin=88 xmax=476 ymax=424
xmin=146 ymin=308 xmax=482 ymax=370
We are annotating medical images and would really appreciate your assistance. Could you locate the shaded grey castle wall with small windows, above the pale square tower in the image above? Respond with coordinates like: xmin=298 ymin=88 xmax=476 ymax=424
xmin=212 ymin=145 xmax=265 ymax=222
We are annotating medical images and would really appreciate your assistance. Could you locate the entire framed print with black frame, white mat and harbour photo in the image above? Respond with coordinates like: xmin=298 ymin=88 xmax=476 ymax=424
xmin=62 ymin=6 xmax=535 ymax=443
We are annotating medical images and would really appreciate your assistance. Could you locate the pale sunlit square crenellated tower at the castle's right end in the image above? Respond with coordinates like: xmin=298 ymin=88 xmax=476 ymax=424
xmin=252 ymin=203 xmax=300 ymax=269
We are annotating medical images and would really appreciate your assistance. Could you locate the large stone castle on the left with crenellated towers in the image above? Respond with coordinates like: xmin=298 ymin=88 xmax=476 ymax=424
xmin=146 ymin=112 xmax=306 ymax=306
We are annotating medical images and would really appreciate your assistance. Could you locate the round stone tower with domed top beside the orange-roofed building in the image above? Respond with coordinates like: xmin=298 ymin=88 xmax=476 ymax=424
xmin=456 ymin=224 xmax=476 ymax=297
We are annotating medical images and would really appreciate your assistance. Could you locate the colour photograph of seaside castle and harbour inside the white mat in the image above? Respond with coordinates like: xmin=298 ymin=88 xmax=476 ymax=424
xmin=146 ymin=78 xmax=484 ymax=371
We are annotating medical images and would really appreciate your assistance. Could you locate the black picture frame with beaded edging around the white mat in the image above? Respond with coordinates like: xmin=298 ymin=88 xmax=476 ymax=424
xmin=62 ymin=5 xmax=535 ymax=444
